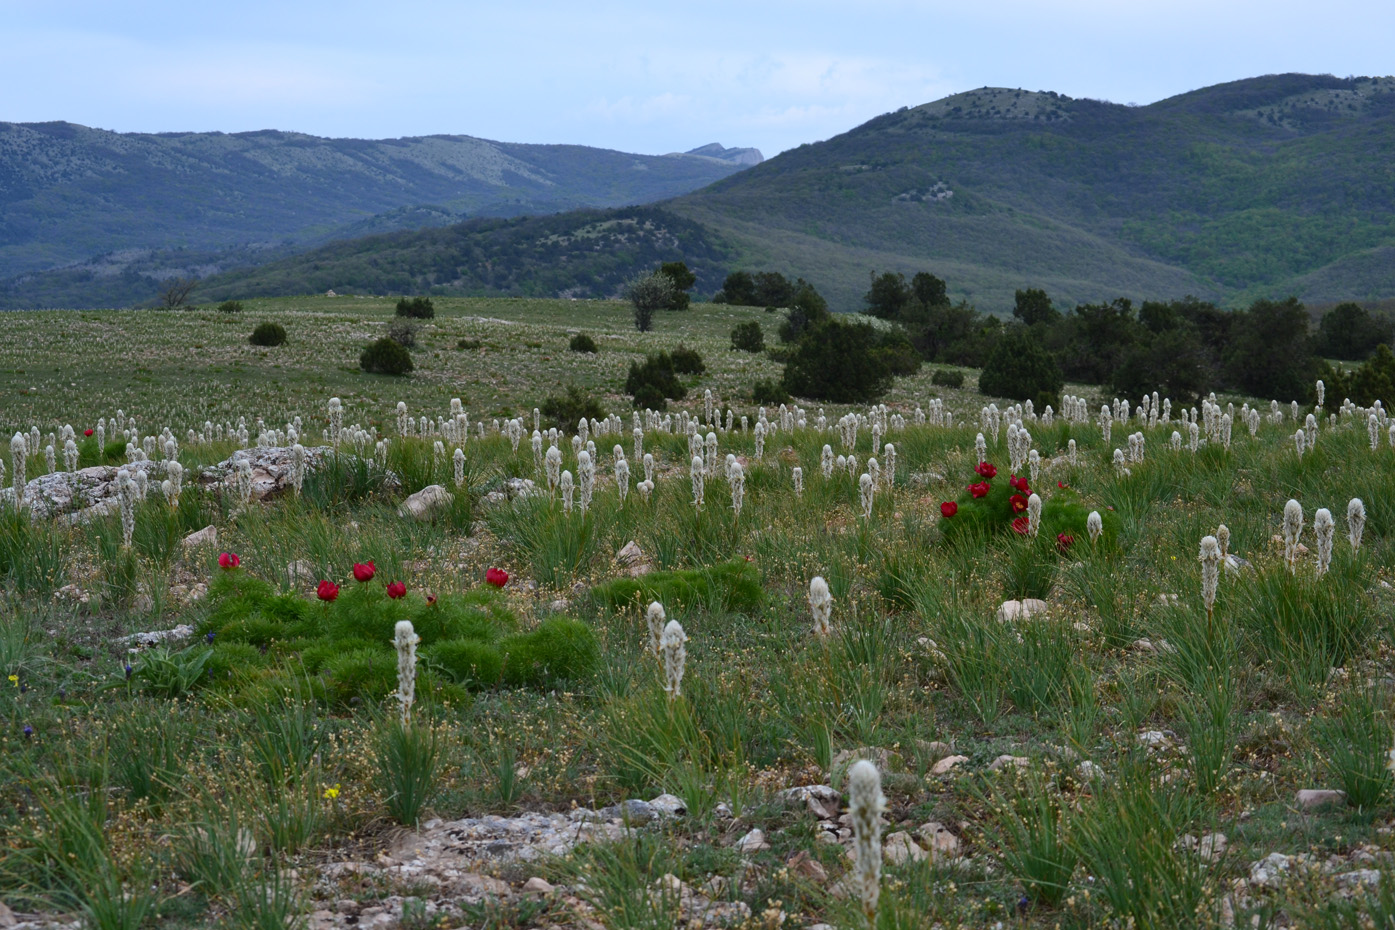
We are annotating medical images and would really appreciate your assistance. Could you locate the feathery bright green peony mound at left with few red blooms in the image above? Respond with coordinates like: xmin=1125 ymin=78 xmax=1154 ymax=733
xmin=199 ymin=572 xmax=600 ymax=704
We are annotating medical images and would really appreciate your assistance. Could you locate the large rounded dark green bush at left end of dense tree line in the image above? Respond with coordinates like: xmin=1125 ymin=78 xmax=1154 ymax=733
xmin=784 ymin=317 xmax=893 ymax=403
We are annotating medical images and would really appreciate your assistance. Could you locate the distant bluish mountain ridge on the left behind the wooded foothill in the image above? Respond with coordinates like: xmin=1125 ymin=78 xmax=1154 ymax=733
xmin=0 ymin=123 xmax=760 ymax=277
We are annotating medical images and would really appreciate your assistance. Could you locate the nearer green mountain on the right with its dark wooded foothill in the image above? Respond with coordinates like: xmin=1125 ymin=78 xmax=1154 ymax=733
xmin=0 ymin=74 xmax=1395 ymax=312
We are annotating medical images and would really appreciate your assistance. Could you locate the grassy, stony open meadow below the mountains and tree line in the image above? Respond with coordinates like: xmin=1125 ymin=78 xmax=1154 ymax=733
xmin=0 ymin=297 xmax=1395 ymax=930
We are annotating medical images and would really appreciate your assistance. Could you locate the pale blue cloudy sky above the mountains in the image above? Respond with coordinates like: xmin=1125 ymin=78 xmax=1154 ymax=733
xmin=0 ymin=0 xmax=1395 ymax=158
